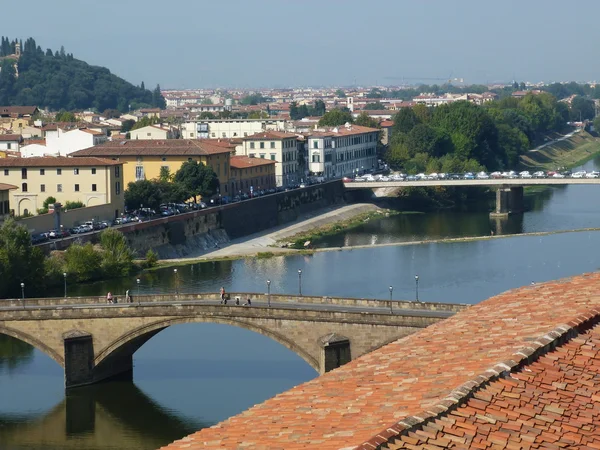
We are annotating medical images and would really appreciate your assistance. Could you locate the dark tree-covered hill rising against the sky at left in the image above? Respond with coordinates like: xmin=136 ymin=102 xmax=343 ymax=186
xmin=0 ymin=37 xmax=165 ymax=112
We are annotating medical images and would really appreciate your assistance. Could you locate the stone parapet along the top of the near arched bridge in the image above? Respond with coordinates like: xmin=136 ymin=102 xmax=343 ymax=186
xmin=0 ymin=292 xmax=468 ymax=312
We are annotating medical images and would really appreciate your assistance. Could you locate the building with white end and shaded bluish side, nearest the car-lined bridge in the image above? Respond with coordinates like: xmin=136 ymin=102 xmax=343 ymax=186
xmin=308 ymin=123 xmax=379 ymax=178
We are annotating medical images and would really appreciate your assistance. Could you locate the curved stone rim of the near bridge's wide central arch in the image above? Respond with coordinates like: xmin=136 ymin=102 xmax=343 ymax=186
xmin=94 ymin=316 xmax=320 ymax=372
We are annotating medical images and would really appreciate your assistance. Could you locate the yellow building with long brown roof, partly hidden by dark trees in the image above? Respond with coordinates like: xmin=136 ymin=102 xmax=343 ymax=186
xmin=71 ymin=139 xmax=235 ymax=195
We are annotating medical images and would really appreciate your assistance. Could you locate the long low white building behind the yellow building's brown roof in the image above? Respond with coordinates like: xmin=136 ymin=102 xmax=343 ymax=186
xmin=182 ymin=119 xmax=286 ymax=139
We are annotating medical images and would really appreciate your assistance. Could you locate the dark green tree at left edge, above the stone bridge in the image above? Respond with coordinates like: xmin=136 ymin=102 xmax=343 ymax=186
xmin=0 ymin=218 xmax=44 ymax=298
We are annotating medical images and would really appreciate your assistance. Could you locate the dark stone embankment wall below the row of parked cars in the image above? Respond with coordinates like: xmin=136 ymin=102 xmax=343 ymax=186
xmin=40 ymin=180 xmax=344 ymax=259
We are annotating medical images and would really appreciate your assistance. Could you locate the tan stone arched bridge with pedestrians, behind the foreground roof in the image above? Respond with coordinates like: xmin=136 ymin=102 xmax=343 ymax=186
xmin=0 ymin=293 xmax=466 ymax=388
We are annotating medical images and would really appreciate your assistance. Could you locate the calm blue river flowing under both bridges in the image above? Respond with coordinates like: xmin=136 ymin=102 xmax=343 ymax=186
xmin=0 ymin=159 xmax=600 ymax=450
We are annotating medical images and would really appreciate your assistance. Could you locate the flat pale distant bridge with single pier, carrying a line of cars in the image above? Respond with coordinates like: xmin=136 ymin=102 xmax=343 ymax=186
xmin=344 ymin=178 xmax=600 ymax=217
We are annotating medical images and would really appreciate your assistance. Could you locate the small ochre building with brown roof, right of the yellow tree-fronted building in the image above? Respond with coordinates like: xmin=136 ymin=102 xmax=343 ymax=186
xmin=229 ymin=155 xmax=278 ymax=195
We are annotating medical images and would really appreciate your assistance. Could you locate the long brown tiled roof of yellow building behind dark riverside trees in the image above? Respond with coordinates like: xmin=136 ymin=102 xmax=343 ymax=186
xmin=71 ymin=139 xmax=235 ymax=157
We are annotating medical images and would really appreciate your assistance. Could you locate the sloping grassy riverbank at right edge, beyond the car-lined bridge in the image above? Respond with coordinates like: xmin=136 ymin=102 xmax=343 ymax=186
xmin=519 ymin=131 xmax=600 ymax=170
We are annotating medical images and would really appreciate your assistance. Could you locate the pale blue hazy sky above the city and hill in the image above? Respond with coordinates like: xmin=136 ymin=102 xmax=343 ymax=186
xmin=0 ymin=0 xmax=600 ymax=88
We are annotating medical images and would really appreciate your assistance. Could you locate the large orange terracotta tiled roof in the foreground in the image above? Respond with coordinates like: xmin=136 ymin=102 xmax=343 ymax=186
xmin=167 ymin=273 xmax=600 ymax=450
